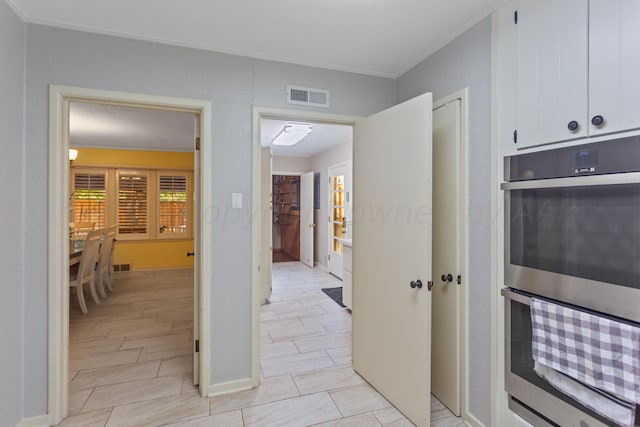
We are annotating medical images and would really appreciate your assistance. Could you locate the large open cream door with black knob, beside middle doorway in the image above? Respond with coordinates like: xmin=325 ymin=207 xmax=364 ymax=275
xmin=352 ymin=93 xmax=432 ymax=427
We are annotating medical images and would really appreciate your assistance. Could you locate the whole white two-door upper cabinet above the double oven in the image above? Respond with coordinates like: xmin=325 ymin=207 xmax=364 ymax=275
xmin=511 ymin=0 xmax=640 ymax=149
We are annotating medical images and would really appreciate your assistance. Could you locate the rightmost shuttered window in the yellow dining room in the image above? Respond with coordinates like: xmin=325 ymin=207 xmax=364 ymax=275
xmin=158 ymin=172 xmax=189 ymax=238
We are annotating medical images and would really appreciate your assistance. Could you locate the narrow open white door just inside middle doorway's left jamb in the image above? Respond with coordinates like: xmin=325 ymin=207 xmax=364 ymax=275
xmin=260 ymin=147 xmax=273 ymax=304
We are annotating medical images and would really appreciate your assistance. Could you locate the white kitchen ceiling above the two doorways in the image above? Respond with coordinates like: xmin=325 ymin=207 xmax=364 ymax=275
xmin=5 ymin=0 xmax=504 ymax=78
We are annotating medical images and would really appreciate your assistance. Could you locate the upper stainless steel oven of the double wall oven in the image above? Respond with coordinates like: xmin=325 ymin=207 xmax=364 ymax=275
xmin=502 ymin=136 xmax=640 ymax=322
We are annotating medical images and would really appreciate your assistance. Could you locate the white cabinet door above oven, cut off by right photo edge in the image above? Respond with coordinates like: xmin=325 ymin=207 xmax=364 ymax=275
xmin=589 ymin=0 xmax=640 ymax=135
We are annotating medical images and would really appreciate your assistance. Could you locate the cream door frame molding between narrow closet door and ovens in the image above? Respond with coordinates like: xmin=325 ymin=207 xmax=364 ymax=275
xmin=433 ymin=87 xmax=468 ymax=425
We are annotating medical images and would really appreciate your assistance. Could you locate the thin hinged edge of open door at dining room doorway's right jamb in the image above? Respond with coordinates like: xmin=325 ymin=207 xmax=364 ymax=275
xmin=193 ymin=114 xmax=203 ymax=386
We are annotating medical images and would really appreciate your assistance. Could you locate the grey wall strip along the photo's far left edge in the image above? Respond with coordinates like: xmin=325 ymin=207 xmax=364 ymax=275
xmin=0 ymin=2 xmax=24 ymax=426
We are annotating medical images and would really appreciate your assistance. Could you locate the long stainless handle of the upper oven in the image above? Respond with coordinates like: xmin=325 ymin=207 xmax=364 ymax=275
xmin=500 ymin=172 xmax=640 ymax=190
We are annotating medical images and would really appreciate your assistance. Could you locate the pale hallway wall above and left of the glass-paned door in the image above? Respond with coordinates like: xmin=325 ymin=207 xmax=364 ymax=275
xmin=311 ymin=141 xmax=353 ymax=266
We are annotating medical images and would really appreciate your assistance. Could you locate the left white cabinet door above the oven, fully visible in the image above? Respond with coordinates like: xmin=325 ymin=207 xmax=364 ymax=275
xmin=516 ymin=0 xmax=589 ymax=148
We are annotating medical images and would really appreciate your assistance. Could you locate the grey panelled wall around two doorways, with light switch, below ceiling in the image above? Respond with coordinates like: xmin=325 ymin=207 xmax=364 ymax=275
xmin=23 ymin=24 xmax=395 ymax=416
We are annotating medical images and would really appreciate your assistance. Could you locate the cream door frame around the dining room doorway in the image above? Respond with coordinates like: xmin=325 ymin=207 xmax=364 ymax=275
xmin=47 ymin=85 xmax=213 ymax=424
